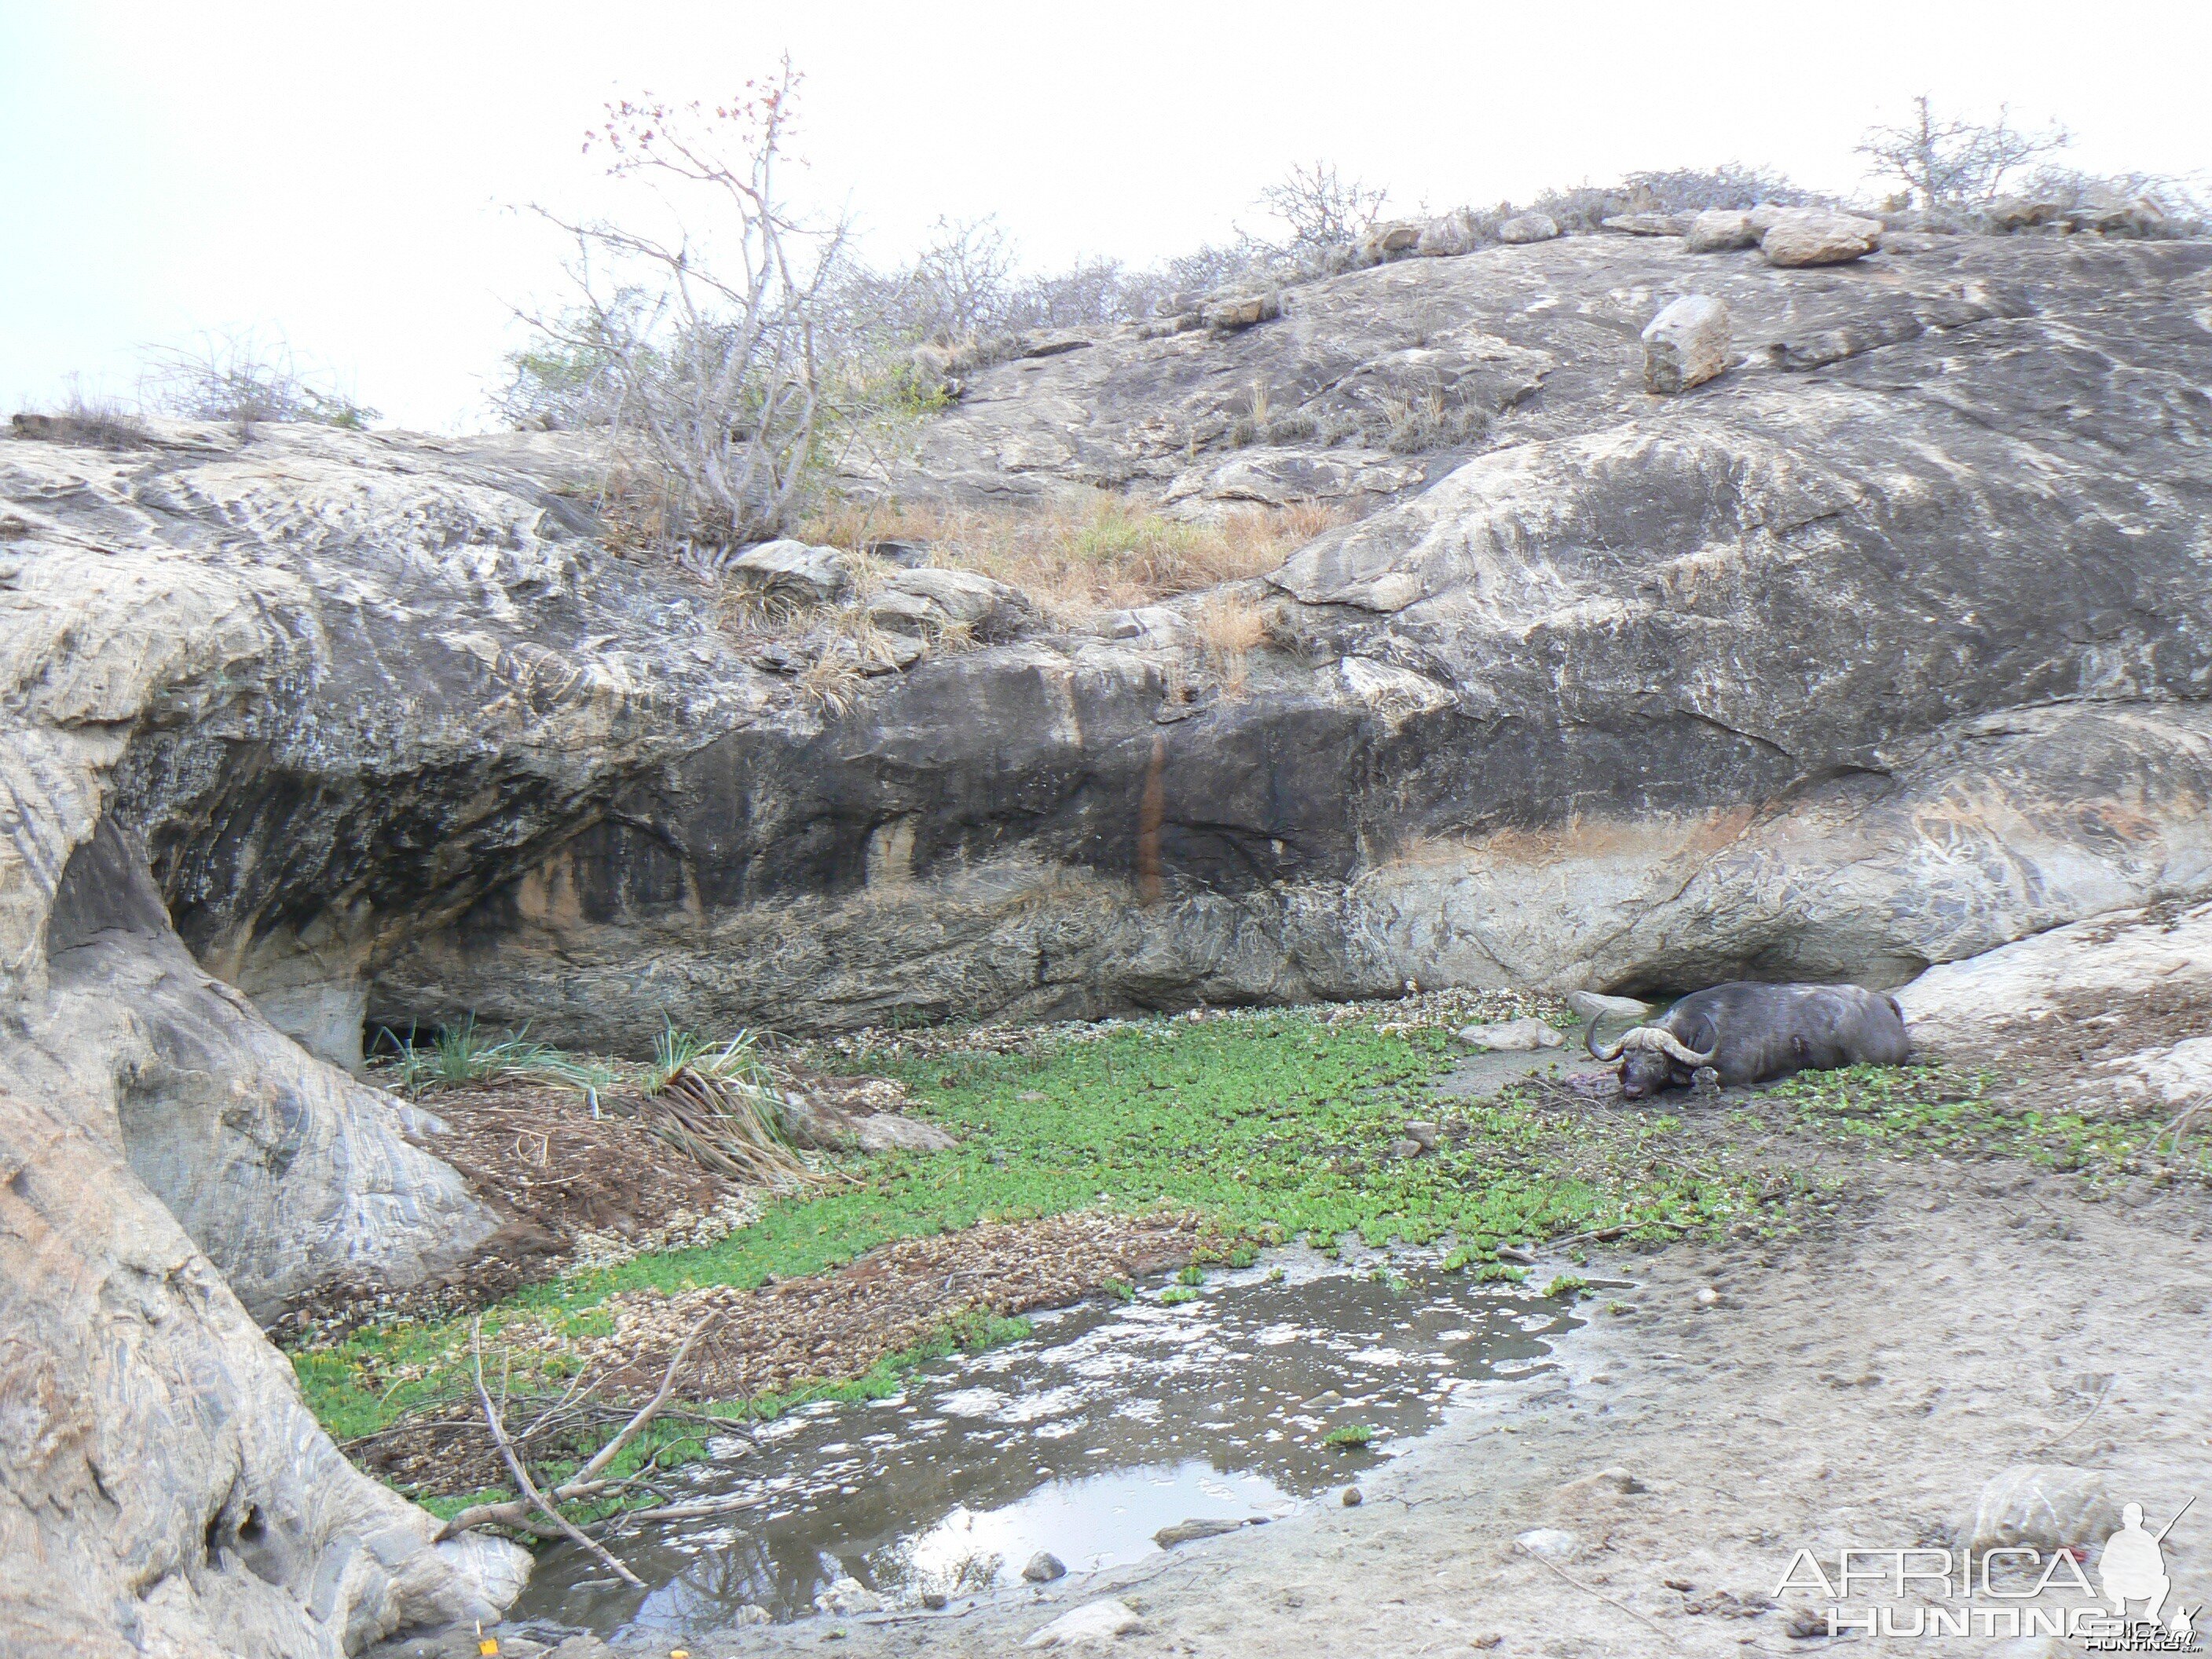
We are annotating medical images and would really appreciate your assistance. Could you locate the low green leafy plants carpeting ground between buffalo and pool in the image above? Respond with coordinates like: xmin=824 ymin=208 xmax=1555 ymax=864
xmin=292 ymin=1011 xmax=2212 ymax=1513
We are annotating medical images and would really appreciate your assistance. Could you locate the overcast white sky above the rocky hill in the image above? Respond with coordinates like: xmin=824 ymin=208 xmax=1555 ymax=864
xmin=0 ymin=0 xmax=2212 ymax=431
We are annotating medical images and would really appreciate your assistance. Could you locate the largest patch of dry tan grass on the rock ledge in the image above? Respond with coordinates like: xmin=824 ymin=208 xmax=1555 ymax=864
xmin=799 ymin=491 xmax=1345 ymax=624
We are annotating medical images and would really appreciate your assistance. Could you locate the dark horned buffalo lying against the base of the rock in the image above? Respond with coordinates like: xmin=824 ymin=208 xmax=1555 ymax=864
xmin=1584 ymin=980 xmax=1914 ymax=1100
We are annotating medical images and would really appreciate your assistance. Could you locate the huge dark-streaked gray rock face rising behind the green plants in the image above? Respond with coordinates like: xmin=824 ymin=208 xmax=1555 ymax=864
xmin=5 ymin=236 xmax=2212 ymax=1046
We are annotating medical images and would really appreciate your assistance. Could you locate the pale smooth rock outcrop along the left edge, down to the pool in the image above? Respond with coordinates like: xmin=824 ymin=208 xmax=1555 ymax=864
xmin=0 ymin=498 xmax=524 ymax=1659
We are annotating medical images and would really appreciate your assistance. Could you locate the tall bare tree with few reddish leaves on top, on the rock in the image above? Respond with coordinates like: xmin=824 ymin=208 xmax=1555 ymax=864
xmin=529 ymin=60 xmax=848 ymax=542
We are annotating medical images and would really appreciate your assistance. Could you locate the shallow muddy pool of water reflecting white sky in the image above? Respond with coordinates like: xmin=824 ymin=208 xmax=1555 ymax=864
xmin=509 ymin=1252 xmax=1575 ymax=1637
